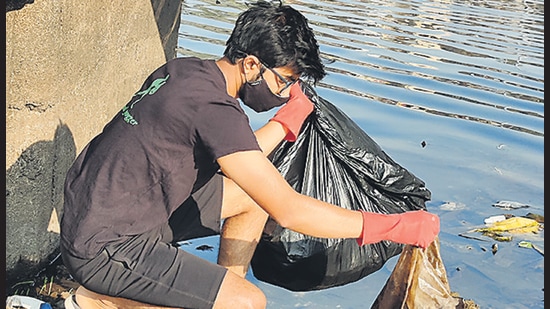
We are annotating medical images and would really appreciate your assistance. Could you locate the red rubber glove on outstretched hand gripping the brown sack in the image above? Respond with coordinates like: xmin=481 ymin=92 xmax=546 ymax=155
xmin=357 ymin=210 xmax=439 ymax=248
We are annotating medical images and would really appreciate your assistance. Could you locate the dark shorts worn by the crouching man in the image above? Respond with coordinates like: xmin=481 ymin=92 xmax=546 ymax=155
xmin=62 ymin=174 xmax=227 ymax=308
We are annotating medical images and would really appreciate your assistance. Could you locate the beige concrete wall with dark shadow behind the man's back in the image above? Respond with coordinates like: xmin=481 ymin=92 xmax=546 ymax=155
xmin=6 ymin=0 xmax=181 ymax=279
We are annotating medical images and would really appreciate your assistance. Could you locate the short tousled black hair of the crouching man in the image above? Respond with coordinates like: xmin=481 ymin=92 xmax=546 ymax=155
xmin=224 ymin=0 xmax=326 ymax=83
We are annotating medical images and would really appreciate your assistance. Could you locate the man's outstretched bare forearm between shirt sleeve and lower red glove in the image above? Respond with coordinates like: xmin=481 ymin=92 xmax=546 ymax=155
xmin=218 ymin=149 xmax=363 ymax=238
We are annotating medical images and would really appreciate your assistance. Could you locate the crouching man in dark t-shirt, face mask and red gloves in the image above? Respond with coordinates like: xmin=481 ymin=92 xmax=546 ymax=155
xmin=61 ymin=2 xmax=439 ymax=308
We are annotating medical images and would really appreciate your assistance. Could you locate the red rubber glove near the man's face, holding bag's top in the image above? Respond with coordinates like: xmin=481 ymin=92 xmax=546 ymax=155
xmin=270 ymin=82 xmax=313 ymax=142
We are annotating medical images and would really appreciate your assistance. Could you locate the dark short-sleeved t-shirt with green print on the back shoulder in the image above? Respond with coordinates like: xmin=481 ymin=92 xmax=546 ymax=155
xmin=61 ymin=57 xmax=260 ymax=258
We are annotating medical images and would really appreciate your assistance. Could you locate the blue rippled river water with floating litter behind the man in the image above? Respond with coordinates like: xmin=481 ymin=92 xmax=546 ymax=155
xmin=178 ymin=0 xmax=544 ymax=309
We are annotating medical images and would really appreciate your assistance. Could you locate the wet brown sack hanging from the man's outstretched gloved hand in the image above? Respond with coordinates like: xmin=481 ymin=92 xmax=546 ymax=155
xmin=371 ymin=238 xmax=467 ymax=309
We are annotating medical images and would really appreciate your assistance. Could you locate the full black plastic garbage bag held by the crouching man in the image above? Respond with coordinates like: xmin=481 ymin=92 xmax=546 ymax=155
xmin=251 ymin=83 xmax=431 ymax=291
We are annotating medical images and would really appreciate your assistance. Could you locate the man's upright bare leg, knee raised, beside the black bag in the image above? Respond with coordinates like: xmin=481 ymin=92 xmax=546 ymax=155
xmin=218 ymin=177 xmax=268 ymax=278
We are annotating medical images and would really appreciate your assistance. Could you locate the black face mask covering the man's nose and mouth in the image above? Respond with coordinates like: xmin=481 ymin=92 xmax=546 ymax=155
xmin=239 ymin=71 xmax=289 ymax=113
